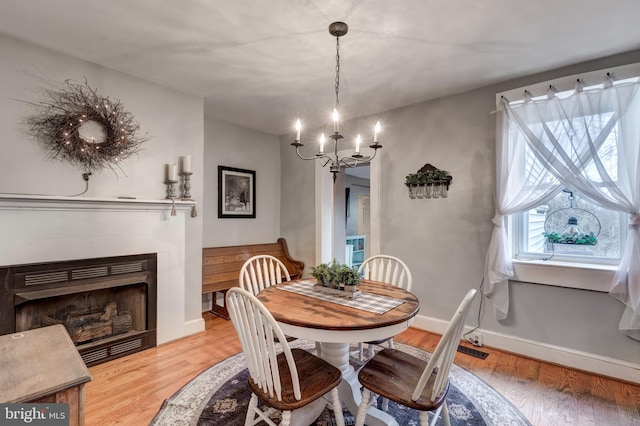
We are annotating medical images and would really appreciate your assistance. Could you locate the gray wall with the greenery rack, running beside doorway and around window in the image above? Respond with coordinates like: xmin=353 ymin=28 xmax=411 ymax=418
xmin=280 ymin=51 xmax=640 ymax=363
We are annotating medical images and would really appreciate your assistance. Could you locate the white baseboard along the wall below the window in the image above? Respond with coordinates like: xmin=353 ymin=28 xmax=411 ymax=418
xmin=411 ymin=315 xmax=640 ymax=384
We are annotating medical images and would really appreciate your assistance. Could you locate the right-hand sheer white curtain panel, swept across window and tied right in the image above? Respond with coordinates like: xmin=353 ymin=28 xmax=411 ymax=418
xmin=494 ymin=82 xmax=640 ymax=339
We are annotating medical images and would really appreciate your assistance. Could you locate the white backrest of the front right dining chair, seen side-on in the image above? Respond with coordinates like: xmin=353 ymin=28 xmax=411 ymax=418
xmin=411 ymin=288 xmax=477 ymax=401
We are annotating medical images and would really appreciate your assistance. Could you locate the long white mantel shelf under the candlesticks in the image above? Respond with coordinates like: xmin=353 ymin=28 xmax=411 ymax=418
xmin=0 ymin=194 xmax=196 ymax=211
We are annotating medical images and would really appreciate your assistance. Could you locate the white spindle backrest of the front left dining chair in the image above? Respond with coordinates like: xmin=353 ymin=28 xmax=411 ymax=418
xmin=226 ymin=287 xmax=301 ymax=401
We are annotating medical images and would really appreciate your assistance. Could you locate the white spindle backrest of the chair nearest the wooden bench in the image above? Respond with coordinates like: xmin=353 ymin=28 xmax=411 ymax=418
xmin=239 ymin=254 xmax=291 ymax=294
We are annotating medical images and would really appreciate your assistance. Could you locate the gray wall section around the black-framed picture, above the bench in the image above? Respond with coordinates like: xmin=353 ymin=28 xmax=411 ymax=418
xmin=203 ymin=119 xmax=280 ymax=247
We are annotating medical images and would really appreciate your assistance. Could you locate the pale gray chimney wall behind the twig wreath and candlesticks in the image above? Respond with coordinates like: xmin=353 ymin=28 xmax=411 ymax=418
xmin=0 ymin=36 xmax=204 ymax=322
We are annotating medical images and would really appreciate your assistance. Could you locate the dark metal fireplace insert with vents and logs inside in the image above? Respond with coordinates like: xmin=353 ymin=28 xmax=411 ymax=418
xmin=0 ymin=253 xmax=157 ymax=366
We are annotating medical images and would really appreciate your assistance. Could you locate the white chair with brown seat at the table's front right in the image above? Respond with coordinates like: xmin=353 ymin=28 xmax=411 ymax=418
xmin=356 ymin=289 xmax=477 ymax=426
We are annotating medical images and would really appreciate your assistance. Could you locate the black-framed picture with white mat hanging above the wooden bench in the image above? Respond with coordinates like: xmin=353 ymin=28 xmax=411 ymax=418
xmin=218 ymin=166 xmax=256 ymax=219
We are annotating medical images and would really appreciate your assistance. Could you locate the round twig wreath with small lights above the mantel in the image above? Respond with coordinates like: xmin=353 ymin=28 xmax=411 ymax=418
xmin=26 ymin=80 xmax=149 ymax=172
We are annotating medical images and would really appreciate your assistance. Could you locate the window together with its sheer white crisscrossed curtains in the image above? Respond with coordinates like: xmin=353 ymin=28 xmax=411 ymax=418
xmin=485 ymin=64 xmax=640 ymax=337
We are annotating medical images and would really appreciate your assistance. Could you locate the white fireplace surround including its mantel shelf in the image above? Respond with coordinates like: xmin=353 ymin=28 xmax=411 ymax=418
xmin=0 ymin=194 xmax=204 ymax=344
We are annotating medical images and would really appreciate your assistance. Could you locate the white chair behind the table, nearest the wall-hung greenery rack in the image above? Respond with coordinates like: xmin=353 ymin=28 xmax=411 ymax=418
xmin=358 ymin=254 xmax=413 ymax=361
